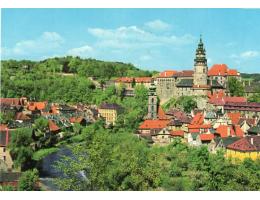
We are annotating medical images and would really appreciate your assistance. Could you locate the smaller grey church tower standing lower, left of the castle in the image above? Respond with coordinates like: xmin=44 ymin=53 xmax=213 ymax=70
xmin=148 ymin=82 xmax=157 ymax=119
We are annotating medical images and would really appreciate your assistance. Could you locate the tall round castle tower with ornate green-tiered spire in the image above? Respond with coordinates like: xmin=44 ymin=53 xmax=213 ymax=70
xmin=193 ymin=36 xmax=208 ymax=86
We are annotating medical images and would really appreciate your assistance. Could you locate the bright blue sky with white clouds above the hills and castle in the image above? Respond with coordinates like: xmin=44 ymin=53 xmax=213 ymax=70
xmin=1 ymin=8 xmax=260 ymax=73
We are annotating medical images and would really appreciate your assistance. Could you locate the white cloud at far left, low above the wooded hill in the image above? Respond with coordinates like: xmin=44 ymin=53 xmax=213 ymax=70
xmin=3 ymin=32 xmax=64 ymax=56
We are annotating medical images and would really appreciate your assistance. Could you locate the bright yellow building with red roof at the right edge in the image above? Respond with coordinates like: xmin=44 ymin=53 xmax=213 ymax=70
xmin=226 ymin=136 xmax=260 ymax=160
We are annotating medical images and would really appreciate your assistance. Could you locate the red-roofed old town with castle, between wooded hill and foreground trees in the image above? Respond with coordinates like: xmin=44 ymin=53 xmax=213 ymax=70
xmin=0 ymin=38 xmax=260 ymax=191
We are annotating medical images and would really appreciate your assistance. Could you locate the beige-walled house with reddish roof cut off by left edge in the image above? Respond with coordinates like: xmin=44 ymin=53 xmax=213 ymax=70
xmin=0 ymin=124 xmax=13 ymax=171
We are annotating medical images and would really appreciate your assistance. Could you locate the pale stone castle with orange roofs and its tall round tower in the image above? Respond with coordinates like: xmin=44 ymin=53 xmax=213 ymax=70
xmin=156 ymin=38 xmax=240 ymax=104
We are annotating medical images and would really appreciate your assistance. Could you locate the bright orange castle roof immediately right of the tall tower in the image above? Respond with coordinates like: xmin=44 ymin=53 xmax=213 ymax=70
xmin=208 ymin=64 xmax=239 ymax=76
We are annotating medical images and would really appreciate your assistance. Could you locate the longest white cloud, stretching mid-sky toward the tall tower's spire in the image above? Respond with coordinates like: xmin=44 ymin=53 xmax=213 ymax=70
xmin=88 ymin=26 xmax=195 ymax=49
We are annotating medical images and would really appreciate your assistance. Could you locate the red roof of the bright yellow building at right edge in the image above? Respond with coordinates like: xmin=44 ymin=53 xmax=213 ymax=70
xmin=227 ymin=136 xmax=260 ymax=152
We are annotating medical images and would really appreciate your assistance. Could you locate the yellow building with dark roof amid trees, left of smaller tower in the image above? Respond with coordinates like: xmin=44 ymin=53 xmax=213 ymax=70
xmin=98 ymin=103 xmax=122 ymax=125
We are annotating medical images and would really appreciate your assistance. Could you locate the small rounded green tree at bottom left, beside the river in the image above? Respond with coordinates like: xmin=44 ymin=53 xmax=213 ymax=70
xmin=18 ymin=169 xmax=39 ymax=191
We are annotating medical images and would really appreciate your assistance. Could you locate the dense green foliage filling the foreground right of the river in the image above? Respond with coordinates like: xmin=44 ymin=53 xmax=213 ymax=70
xmin=55 ymin=126 xmax=260 ymax=191
